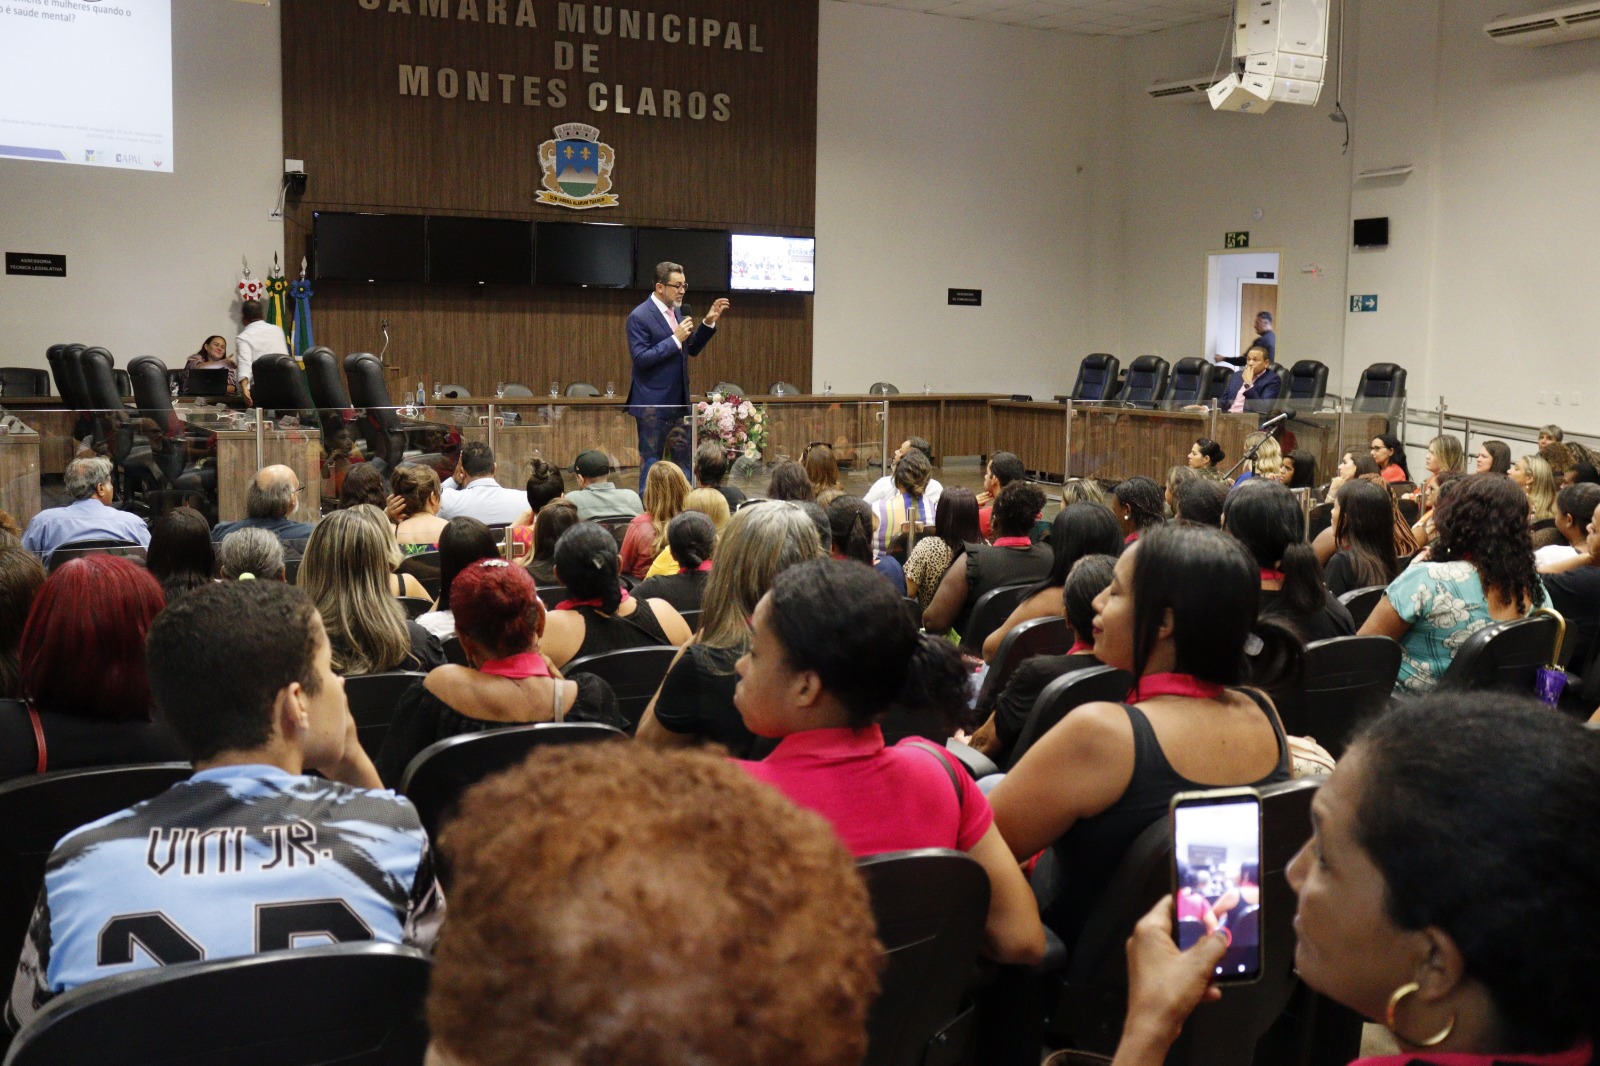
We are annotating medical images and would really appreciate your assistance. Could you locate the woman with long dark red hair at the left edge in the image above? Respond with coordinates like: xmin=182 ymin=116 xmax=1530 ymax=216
xmin=0 ymin=555 xmax=181 ymax=779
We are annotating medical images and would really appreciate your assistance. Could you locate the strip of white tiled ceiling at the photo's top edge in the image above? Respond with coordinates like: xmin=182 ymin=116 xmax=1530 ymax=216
xmin=846 ymin=0 xmax=1234 ymax=37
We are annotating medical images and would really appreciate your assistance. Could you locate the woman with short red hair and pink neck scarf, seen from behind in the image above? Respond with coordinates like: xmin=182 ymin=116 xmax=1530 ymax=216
xmin=376 ymin=557 xmax=624 ymax=787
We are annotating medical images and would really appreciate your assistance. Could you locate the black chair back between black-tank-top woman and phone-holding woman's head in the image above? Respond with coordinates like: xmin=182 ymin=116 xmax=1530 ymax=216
xmin=1278 ymin=637 xmax=1400 ymax=759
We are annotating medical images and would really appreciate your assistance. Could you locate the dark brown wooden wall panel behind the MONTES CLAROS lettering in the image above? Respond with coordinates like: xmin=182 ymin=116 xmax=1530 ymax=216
xmin=282 ymin=0 xmax=818 ymax=392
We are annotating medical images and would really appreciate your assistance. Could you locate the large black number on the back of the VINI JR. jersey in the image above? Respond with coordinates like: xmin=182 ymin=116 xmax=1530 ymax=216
xmin=96 ymin=900 xmax=373 ymax=967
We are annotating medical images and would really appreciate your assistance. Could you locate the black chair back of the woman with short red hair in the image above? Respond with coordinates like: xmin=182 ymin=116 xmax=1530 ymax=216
xmin=400 ymin=722 xmax=627 ymax=858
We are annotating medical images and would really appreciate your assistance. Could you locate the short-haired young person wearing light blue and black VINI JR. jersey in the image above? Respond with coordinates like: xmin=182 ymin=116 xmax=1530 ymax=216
xmin=6 ymin=563 xmax=445 ymax=1028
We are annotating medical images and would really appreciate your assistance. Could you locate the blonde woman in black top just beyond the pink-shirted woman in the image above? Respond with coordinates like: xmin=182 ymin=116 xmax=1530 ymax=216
xmin=638 ymin=503 xmax=827 ymax=759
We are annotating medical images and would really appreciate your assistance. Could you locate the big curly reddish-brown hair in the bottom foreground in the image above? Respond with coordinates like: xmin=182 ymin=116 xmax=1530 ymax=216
xmin=427 ymin=743 xmax=880 ymax=1066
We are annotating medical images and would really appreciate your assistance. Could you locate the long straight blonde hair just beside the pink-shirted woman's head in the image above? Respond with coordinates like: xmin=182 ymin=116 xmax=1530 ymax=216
xmin=694 ymin=490 xmax=827 ymax=653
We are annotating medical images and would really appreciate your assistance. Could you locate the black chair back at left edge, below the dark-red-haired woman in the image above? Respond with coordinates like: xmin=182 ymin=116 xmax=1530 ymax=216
xmin=0 ymin=762 xmax=194 ymax=985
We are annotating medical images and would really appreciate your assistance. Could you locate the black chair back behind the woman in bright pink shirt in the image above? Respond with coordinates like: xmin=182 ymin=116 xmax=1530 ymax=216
xmin=856 ymin=848 xmax=989 ymax=1066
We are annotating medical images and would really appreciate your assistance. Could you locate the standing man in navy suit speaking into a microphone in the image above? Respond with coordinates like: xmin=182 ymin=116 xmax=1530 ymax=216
xmin=627 ymin=262 xmax=728 ymax=491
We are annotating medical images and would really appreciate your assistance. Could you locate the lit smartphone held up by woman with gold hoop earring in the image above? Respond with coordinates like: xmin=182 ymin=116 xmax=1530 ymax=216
xmin=1173 ymin=789 xmax=1261 ymax=981
